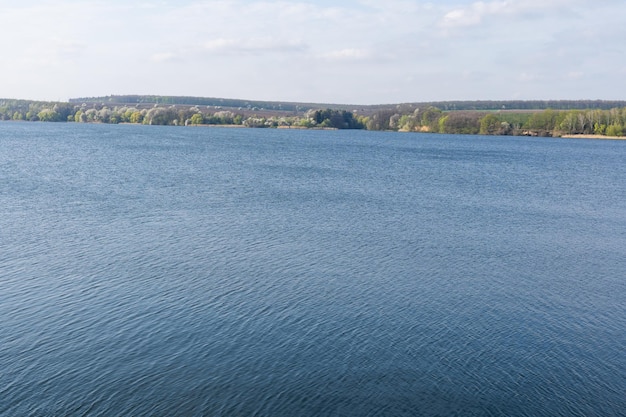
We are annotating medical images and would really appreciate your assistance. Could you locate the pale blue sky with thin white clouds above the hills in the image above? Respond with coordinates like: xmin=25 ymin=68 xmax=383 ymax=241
xmin=0 ymin=0 xmax=626 ymax=104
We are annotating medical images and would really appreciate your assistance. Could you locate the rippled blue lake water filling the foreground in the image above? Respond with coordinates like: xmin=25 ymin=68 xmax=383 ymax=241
xmin=0 ymin=122 xmax=626 ymax=416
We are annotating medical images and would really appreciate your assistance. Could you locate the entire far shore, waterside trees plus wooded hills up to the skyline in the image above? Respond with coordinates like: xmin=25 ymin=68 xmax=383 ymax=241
xmin=0 ymin=96 xmax=626 ymax=137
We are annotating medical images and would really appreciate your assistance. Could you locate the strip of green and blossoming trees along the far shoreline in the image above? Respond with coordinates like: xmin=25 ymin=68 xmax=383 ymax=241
xmin=0 ymin=100 xmax=626 ymax=136
